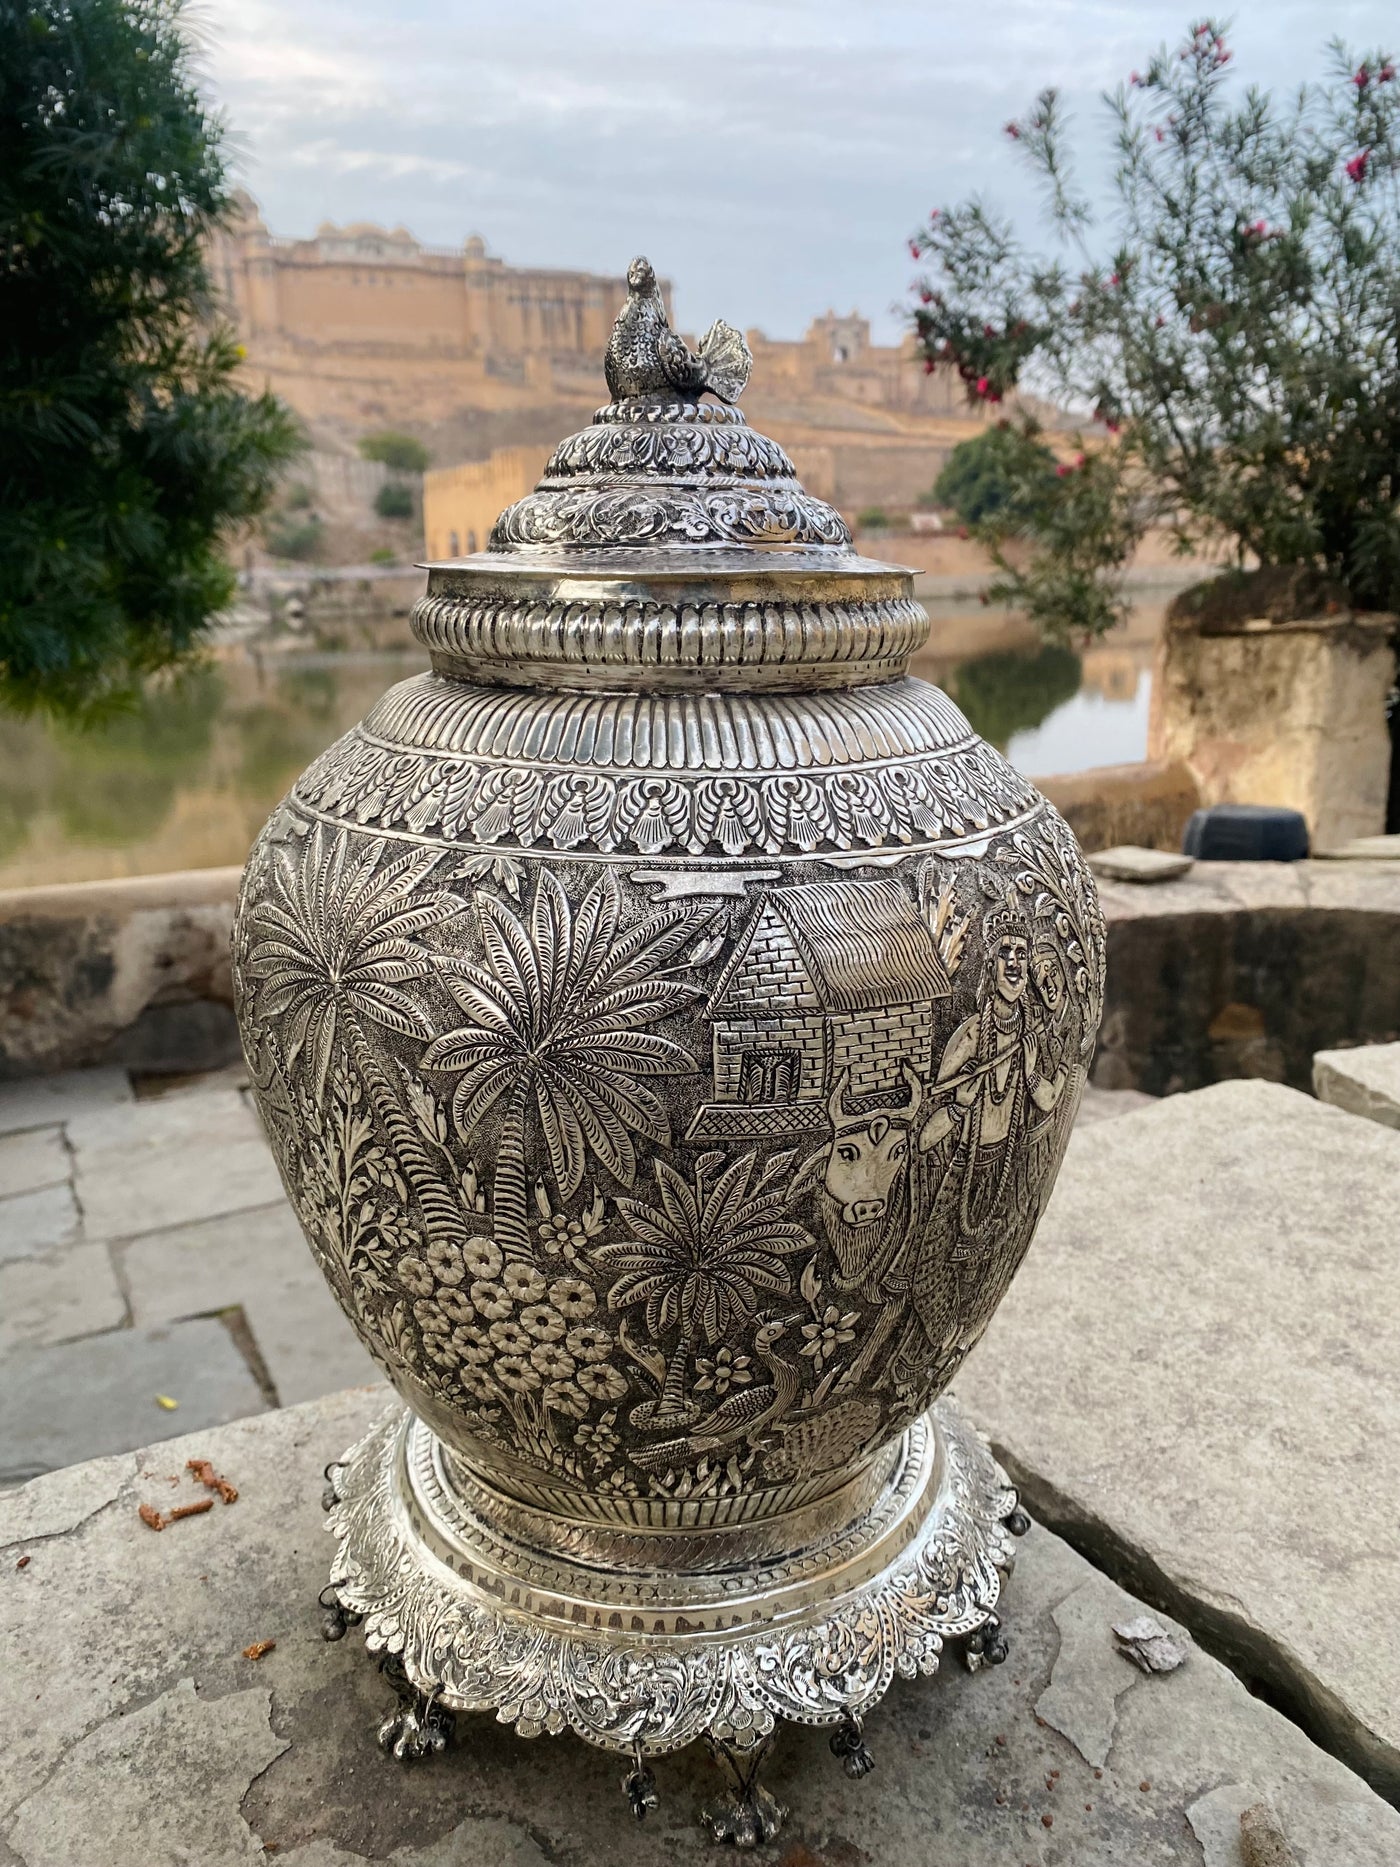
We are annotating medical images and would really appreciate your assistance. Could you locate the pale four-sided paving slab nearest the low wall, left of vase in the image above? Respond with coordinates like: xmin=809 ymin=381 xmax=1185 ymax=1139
xmin=67 ymin=1088 xmax=282 ymax=1238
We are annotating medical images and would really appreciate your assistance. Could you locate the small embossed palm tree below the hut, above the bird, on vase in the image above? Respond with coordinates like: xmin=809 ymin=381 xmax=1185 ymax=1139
xmin=594 ymin=1152 xmax=812 ymax=1430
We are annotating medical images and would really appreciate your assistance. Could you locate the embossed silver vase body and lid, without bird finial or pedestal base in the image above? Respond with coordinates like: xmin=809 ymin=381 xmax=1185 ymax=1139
xmin=233 ymin=382 xmax=1103 ymax=1566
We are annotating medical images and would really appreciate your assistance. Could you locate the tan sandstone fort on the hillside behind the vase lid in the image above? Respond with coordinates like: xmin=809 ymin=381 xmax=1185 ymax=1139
xmin=215 ymin=194 xmax=1022 ymax=556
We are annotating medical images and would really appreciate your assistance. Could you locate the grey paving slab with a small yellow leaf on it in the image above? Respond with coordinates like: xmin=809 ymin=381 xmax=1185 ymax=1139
xmin=0 ymin=1318 xmax=267 ymax=1478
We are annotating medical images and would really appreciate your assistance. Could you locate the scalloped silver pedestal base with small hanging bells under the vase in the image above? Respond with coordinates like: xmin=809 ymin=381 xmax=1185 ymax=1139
xmin=323 ymin=1400 xmax=1025 ymax=1845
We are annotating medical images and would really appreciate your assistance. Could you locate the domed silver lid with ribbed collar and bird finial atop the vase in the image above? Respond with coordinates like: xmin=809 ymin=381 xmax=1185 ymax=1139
xmin=413 ymin=258 xmax=928 ymax=691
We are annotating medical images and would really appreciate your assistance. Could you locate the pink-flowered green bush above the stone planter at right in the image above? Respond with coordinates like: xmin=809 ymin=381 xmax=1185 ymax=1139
xmin=911 ymin=21 xmax=1400 ymax=639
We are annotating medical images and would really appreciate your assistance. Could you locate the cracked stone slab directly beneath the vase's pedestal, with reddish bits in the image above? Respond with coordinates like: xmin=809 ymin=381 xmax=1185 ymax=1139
xmin=0 ymin=1389 xmax=1400 ymax=1867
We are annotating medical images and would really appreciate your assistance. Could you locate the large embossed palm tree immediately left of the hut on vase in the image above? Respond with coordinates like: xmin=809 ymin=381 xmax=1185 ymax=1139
xmin=422 ymin=872 xmax=713 ymax=1256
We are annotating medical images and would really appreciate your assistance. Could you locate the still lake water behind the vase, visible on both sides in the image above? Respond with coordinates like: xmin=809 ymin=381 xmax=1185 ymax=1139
xmin=0 ymin=620 xmax=1150 ymax=889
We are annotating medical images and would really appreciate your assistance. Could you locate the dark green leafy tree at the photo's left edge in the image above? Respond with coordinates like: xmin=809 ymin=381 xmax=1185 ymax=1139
xmin=0 ymin=0 xmax=301 ymax=717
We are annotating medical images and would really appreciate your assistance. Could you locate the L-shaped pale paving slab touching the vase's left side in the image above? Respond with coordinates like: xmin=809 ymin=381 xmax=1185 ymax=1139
xmin=118 ymin=1200 xmax=379 ymax=1406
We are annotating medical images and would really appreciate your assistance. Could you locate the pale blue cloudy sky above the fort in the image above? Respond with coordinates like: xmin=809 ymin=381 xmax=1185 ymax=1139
xmin=196 ymin=0 xmax=1400 ymax=342
